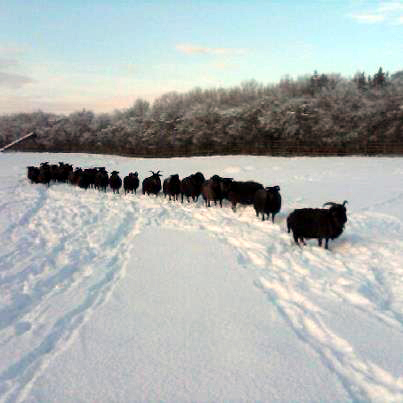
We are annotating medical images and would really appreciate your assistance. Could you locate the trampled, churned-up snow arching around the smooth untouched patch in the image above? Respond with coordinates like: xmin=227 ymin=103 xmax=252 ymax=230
xmin=0 ymin=153 xmax=403 ymax=401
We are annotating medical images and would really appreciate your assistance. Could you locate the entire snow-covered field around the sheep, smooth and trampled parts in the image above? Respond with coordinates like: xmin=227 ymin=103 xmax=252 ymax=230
xmin=0 ymin=153 xmax=403 ymax=402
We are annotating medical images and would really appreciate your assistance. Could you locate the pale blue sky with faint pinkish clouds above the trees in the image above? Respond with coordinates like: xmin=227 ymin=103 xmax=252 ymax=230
xmin=0 ymin=0 xmax=403 ymax=114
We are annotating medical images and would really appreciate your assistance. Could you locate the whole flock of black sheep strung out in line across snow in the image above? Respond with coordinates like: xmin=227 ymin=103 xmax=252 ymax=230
xmin=27 ymin=162 xmax=347 ymax=249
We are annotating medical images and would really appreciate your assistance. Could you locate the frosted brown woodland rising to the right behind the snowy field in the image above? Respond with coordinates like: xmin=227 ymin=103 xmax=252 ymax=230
xmin=0 ymin=68 xmax=403 ymax=157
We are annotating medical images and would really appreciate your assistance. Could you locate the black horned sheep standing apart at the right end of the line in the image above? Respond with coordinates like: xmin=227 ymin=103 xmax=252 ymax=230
xmin=287 ymin=200 xmax=347 ymax=249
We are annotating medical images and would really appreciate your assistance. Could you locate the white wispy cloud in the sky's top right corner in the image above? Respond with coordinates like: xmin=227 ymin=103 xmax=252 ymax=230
xmin=350 ymin=0 xmax=403 ymax=24
